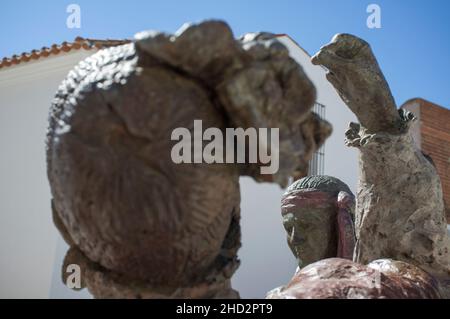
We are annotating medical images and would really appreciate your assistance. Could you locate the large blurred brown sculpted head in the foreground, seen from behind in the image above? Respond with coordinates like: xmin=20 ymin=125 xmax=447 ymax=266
xmin=47 ymin=21 xmax=331 ymax=298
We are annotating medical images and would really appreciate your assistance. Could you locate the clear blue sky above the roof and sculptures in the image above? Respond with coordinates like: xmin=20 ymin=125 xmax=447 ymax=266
xmin=0 ymin=0 xmax=450 ymax=107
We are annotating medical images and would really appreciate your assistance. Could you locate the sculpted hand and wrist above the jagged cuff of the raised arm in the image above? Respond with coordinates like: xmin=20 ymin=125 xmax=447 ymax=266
xmin=311 ymin=34 xmax=401 ymax=133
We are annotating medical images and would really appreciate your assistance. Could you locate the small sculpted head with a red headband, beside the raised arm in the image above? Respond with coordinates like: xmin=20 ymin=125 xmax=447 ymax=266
xmin=281 ymin=176 xmax=354 ymax=267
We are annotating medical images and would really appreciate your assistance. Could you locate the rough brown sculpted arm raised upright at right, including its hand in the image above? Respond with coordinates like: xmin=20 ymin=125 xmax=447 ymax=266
xmin=312 ymin=34 xmax=450 ymax=288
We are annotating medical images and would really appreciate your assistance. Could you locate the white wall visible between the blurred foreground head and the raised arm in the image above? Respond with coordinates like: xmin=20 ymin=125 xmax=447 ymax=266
xmin=233 ymin=36 xmax=358 ymax=298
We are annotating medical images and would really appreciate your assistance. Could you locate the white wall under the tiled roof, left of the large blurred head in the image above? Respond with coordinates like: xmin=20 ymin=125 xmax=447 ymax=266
xmin=0 ymin=51 xmax=92 ymax=298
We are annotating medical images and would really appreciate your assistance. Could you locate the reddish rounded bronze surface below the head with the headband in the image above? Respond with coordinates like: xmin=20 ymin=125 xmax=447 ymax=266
xmin=267 ymin=258 xmax=441 ymax=299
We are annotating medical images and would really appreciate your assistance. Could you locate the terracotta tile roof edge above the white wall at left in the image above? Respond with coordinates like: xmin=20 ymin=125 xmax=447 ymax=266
xmin=0 ymin=37 xmax=130 ymax=69
